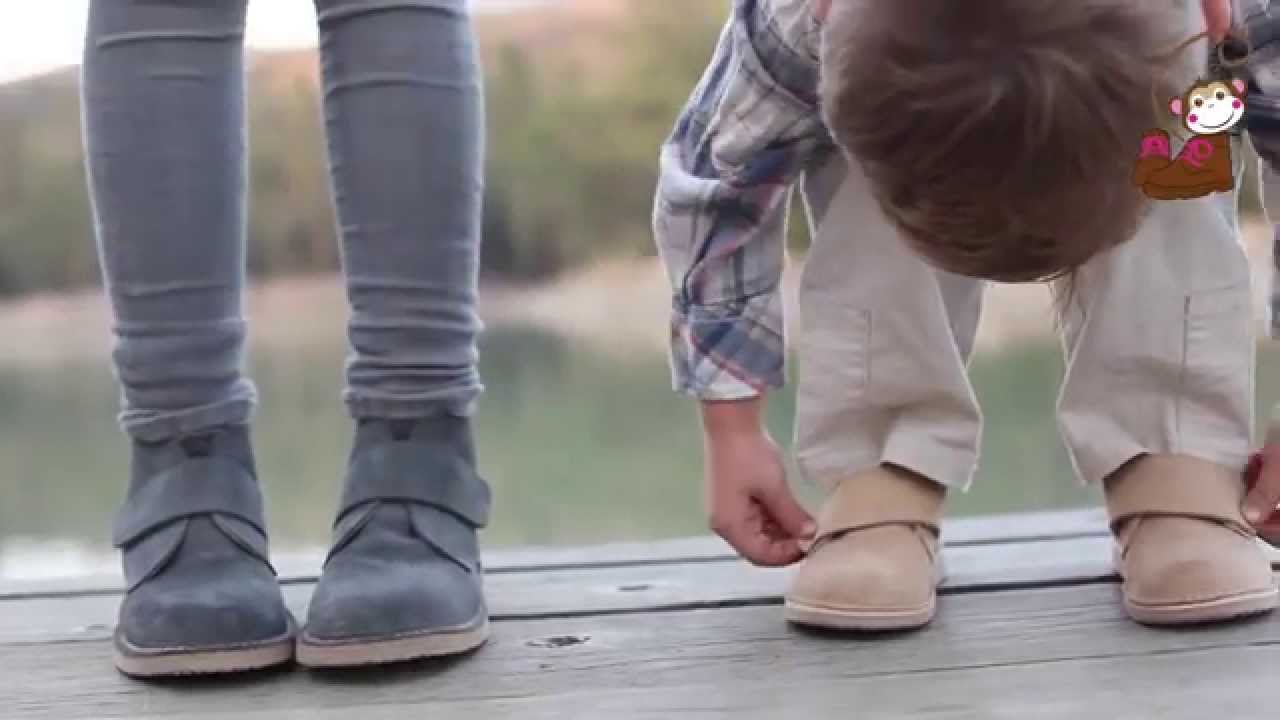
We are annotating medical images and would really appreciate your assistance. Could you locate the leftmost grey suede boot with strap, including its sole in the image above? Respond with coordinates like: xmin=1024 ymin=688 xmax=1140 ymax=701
xmin=113 ymin=427 xmax=294 ymax=676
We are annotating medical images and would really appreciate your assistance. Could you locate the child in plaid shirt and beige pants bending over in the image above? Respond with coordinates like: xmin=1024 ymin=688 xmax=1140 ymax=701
xmin=654 ymin=0 xmax=1277 ymax=628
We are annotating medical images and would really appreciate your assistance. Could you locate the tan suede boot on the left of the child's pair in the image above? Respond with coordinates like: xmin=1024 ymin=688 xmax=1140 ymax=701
xmin=786 ymin=468 xmax=945 ymax=630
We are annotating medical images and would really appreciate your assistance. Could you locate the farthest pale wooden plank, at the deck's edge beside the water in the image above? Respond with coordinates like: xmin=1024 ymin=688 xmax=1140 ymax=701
xmin=0 ymin=509 xmax=1107 ymax=600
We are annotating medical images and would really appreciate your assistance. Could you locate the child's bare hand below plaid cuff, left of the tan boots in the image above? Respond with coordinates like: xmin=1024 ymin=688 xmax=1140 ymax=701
xmin=703 ymin=400 xmax=817 ymax=566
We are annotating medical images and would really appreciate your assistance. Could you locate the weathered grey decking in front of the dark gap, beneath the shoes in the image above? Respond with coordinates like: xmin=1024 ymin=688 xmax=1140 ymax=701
xmin=0 ymin=584 xmax=1280 ymax=720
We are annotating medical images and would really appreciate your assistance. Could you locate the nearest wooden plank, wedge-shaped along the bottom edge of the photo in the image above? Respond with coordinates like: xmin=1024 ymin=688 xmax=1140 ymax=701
xmin=140 ymin=646 xmax=1280 ymax=720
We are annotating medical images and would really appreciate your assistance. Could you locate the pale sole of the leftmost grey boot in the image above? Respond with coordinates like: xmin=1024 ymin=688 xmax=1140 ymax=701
xmin=113 ymin=619 xmax=296 ymax=678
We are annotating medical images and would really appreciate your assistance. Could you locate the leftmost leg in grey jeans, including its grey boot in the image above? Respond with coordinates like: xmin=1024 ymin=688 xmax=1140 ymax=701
xmin=83 ymin=0 xmax=292 ymax=675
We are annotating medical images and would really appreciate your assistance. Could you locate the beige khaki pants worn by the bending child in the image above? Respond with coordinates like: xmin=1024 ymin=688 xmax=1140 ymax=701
xmin=792 ymin=143 xmax=1256 ymax=488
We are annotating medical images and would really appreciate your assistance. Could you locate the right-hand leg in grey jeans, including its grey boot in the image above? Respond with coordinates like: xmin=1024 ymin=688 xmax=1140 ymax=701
xmin=298 ymin=0 xmax=489 ymax=666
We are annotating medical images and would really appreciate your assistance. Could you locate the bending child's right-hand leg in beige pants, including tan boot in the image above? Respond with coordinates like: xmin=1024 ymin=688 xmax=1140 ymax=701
xmin=1059 ymin=141 xmax=1276 ymax=624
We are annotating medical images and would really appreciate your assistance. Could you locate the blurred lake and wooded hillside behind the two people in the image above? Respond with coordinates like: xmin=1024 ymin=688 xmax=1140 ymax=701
xmin=0 ymin=0 xmax=1280 ymax=582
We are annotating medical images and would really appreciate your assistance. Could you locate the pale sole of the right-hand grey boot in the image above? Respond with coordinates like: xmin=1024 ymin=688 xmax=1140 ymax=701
xmin=296 ymin=620 xmax=489 ymax=669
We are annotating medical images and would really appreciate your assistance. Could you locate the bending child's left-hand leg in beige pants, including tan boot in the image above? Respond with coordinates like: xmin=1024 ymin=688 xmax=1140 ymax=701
xmin=787 ymin=154 xmax=983 ymax=629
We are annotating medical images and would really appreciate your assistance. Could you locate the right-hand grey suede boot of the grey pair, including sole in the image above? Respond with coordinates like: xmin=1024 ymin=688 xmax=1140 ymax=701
xmin=297 ymin=415 xmax=490 ymax=667
